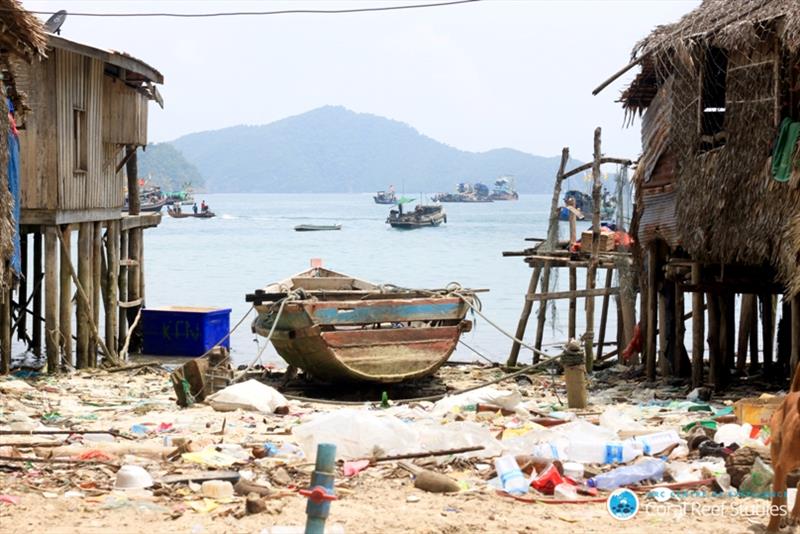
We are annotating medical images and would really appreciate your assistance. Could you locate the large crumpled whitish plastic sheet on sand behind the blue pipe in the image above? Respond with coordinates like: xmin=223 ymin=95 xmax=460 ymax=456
xmin=292 ymin=409 xmax=502 ymax=461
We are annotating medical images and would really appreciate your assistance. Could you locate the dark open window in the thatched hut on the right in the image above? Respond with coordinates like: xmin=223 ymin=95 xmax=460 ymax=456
xmin=700 ymin=47 xmax=728 ymax=150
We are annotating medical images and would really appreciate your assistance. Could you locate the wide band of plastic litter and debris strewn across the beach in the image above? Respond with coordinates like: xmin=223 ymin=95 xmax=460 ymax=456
xmin=0 ymin=366 xmax=780 ymax=524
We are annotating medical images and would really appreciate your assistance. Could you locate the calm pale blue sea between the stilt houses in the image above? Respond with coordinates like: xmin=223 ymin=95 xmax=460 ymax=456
xmin=145 ymin=194 xmax=615 ymax=370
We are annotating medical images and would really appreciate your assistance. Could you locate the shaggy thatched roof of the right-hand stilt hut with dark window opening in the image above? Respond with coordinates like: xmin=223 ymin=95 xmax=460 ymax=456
xmin=620 ymin=0 xmax=800 ymax=113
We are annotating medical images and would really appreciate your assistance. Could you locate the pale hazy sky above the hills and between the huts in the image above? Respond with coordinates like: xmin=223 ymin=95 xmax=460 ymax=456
xmin=23 ymin=0 xmax=699 ymax=159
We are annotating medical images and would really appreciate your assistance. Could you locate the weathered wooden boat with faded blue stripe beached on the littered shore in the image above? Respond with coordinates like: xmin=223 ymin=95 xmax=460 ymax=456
xmin=246 ymin=267 xmax=475 ymax=383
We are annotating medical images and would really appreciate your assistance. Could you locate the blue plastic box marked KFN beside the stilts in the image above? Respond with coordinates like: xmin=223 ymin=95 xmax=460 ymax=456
xmin=142 ymin=306 xmax=231 ymax=356
